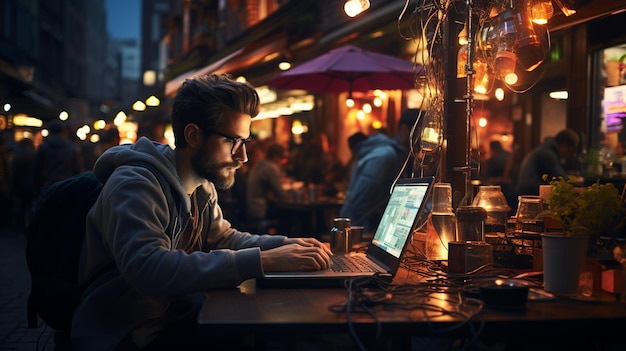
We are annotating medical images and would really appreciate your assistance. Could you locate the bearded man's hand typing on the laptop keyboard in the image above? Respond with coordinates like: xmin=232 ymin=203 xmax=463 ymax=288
xmin=261 ymin=238 xmax=332 ymax=272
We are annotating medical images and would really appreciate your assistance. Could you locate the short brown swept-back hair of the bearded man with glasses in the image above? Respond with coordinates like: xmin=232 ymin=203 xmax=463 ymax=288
xmin=171 ymin=74 xmax=260 ymax=147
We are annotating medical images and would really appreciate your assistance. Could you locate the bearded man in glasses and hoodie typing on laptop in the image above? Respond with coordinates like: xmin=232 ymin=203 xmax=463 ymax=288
xmin=71 ymin=75 xmax=331 ymax=351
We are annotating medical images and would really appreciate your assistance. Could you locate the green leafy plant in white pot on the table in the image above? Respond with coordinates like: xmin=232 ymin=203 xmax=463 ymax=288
xmin=539 ymin=175 xmax=626 ymax=294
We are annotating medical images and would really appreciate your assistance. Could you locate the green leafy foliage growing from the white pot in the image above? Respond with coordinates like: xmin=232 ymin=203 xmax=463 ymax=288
xmin=541 ymin=175 xmax=626 ymax=238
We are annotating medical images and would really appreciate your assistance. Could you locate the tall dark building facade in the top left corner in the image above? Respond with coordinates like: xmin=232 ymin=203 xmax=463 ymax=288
xmin=0 ymin=0 xmax=120 ymax=142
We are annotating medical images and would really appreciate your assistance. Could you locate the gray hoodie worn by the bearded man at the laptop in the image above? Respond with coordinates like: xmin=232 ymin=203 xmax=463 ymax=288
xmin=72 ymin=138 xmax=285 ymax=351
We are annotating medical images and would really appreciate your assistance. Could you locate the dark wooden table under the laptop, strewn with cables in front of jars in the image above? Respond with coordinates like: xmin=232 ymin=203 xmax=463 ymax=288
xmin=198 ymin=274 xmax=626 ymax=350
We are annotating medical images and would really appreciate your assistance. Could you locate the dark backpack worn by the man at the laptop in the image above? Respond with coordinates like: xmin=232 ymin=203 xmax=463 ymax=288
xmin=26 ymin=163 xmax=178 ymax=332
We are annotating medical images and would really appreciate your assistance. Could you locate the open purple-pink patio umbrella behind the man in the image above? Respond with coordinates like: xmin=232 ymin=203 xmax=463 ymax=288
xmin=267 ymin=45 xmax=424 ymax=93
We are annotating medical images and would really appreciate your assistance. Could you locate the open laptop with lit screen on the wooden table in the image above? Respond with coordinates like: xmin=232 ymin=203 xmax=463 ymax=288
xmin=257 ymin=177 xmax=433 ymax=287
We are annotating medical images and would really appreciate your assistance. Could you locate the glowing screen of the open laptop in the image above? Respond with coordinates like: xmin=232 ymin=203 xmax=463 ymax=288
xmin=372 ymin=178 xmax=432 ymax=258
